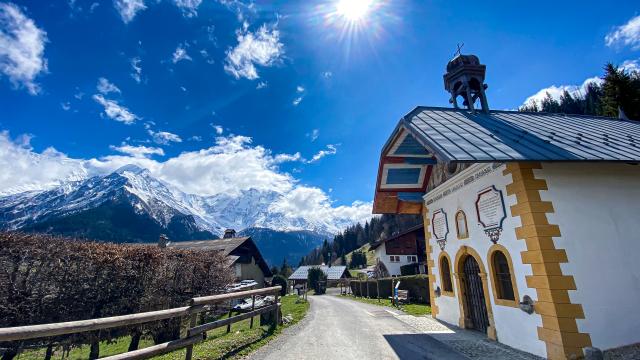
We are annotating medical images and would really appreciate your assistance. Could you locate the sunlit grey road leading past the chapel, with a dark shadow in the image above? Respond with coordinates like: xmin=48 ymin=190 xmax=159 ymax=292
xmin=250 ymin=295 xmax=468 ymax=360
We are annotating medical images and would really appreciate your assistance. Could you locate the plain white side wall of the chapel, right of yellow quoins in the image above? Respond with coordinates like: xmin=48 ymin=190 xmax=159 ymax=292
xmin=536 ymin=163 xmax=640 ymax=349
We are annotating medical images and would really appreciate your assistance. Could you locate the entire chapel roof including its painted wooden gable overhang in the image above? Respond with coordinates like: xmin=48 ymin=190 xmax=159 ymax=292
xmin=373 ymin=106 xmax=640 ymax=214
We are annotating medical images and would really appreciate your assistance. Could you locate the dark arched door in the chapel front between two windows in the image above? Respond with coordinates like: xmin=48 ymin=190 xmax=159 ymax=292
xmin=461 ymin=255 xmax=490 ymax=333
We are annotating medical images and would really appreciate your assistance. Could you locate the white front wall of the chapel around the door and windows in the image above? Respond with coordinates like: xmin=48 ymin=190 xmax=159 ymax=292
xmin=425 ymin=164 xmax=546 ymax=356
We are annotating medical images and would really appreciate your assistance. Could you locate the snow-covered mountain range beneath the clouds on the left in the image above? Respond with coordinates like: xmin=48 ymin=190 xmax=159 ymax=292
xmin=0 ymin=165 xmax=350 ymax=261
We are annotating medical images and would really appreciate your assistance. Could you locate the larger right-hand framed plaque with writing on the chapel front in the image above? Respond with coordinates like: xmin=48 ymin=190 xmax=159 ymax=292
xmin=476 ymin=186 xmax=507 ymax=243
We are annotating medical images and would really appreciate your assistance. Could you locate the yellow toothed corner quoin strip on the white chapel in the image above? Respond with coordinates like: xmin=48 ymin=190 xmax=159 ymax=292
xmin=503 ymin=162 xmax=591 ymax=359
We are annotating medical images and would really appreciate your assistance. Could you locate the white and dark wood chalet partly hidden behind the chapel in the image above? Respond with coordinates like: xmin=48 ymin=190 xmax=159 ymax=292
xmin=370 ymin=224 xmax=426 ymax=276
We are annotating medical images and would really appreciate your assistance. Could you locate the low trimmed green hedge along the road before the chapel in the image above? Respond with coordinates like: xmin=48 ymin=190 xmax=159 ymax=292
xmin=350 ymin=274 xmax=430 ymax=304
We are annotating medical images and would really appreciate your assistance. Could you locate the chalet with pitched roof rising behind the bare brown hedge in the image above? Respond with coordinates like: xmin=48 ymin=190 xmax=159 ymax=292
xmin=166 ymin=230 xmax=272 ymax=287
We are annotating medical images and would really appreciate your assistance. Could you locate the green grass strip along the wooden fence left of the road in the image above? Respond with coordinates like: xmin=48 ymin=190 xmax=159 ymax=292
xmin=16 ymin=295 xmax=309 ymax=360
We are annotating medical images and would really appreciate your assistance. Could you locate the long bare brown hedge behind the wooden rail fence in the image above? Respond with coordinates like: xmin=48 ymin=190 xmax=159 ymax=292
xmin=0 ymin=232 xmax=233 ymax=358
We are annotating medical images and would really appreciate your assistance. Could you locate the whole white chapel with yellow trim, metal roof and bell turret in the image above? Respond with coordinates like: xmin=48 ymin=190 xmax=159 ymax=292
xmin=373 ymin=55 xmax=640 ymax=359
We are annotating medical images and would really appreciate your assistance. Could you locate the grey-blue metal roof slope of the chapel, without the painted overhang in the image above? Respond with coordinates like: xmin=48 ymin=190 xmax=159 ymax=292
xmin=398 ymin=107 xmax=640 ymax=162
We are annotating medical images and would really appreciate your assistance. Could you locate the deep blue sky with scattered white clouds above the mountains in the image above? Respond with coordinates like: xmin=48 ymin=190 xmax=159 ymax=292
xmin=0 ymin=0 xmax=640 ymax=218
